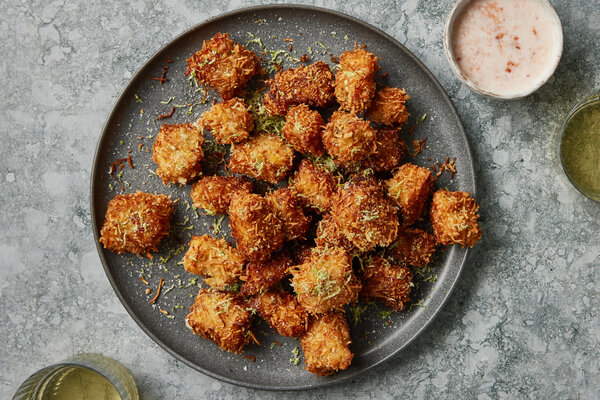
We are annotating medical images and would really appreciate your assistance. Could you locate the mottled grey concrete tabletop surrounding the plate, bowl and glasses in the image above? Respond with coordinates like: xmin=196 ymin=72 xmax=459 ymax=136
xmin=0 ymin=0 xmax=600 ymax=399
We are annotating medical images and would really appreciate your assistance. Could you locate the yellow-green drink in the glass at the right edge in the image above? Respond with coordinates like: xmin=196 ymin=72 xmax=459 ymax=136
xmin=560 ymin=99 xmax=600 ymax=201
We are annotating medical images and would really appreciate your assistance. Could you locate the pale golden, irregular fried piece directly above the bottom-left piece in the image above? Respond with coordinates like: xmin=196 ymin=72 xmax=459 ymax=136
xmin=183 ymin=235 xmax=244 ymax=289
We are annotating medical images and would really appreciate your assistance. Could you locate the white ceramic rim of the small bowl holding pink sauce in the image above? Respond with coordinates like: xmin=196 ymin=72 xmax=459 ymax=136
xmin=444 ymin=0 xmax=563 ymax=100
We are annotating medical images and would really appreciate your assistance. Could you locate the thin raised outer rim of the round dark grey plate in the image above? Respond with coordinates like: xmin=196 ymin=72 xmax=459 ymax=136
xmin=90 ymin=4 xmax=477 ymax=392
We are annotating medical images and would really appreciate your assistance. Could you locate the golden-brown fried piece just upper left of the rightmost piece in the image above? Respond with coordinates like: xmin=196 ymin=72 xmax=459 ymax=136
xmin=385 ymin=163 xmax=433 ymax=226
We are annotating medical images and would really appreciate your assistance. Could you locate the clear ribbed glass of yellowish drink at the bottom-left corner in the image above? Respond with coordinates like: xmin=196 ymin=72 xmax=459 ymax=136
xmin=13 ymin=353 xmax=140 ymax=400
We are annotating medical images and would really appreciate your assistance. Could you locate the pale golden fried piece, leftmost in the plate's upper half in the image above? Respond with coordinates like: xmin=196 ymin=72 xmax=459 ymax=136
xmin=152 ymin=123 xmax=204 ymax=185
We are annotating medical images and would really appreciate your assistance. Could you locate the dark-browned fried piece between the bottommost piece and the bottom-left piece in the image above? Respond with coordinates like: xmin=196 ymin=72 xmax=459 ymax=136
xmin=250 ymin=290 xmax=308 ymax=337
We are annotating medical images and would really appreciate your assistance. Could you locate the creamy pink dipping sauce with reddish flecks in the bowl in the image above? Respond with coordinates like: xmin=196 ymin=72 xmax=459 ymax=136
xmin=451 ymin=0 xmax=562 ymax=97
